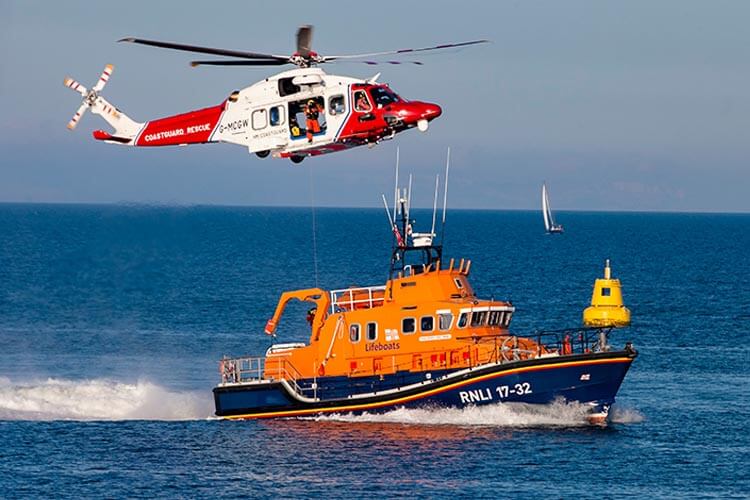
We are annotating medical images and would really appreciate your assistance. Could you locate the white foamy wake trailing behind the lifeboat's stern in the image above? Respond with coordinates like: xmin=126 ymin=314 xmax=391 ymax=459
xmin=0 ymin=378 xmax=212 ymax=420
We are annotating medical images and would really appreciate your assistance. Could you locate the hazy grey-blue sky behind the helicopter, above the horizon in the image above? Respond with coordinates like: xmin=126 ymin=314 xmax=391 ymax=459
xmin=0 ymin=0 xmax=750 ymax=212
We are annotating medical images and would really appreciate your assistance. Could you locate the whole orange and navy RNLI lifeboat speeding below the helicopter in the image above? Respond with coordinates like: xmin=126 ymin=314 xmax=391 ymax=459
xmin=214 ymin=160 xmax=636 ymax=426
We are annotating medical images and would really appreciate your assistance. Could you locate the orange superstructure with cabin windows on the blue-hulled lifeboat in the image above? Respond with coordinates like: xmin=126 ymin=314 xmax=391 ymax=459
xmin=265 ymin=259 xmax=538 ymax=378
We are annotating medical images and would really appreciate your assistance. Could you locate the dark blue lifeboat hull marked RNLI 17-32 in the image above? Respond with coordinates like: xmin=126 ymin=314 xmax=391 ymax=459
xmin=214 ymin=351 xmax=637 ymax=418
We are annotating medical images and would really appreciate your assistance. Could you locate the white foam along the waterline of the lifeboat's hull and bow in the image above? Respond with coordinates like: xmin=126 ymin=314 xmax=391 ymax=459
xmin=315 ymin=401 xmax=643 ymax=427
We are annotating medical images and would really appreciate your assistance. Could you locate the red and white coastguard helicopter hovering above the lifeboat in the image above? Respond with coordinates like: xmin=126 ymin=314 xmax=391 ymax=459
xmin=65 ymin=26 xmax=487 ymax=163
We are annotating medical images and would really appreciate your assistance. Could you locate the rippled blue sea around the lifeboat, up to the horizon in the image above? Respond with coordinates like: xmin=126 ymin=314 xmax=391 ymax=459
xmin=0 ymin=204 xmax=750 ymax=498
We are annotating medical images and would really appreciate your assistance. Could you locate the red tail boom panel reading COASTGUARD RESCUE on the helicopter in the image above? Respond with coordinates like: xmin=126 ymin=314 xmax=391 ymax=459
xmin=135 ymin=103 xmax=225 ymax=146
